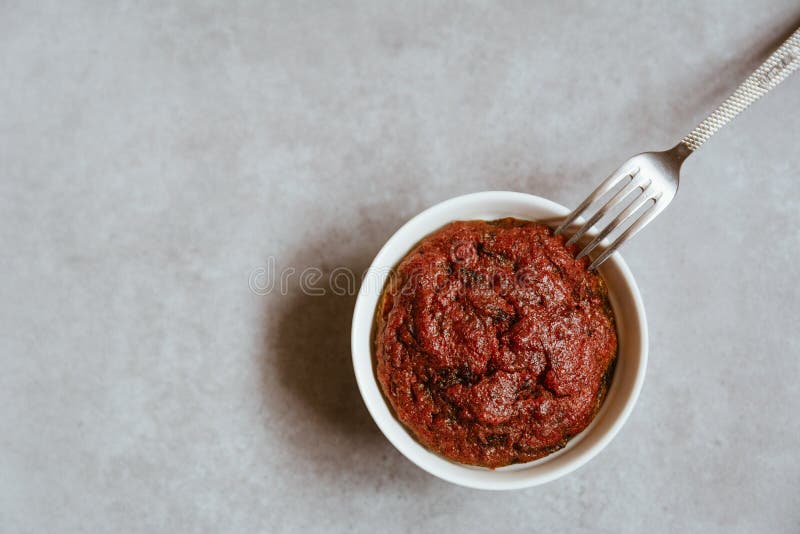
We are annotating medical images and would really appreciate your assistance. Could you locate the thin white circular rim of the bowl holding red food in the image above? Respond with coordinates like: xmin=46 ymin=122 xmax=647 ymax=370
xmin=351 ymin=191 xmax=648 ymax=490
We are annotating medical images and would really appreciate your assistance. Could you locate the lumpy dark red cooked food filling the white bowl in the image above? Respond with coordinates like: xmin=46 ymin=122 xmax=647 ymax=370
xmin=375 ymin=219 xmax=617 ymax=467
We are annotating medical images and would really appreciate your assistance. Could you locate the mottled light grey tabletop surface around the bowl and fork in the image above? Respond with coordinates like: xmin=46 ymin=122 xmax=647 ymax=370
xmin=0 ymin=0 xmax=800 ymax=533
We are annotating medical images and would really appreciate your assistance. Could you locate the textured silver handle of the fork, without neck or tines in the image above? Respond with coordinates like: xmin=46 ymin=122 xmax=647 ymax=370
xmin=679 ymin=28 xmax=800 ymax=156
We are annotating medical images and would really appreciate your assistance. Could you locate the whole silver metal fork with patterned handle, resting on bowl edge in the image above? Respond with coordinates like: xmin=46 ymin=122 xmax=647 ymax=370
xmin=555 ymin=28 xmax=800 ymax=269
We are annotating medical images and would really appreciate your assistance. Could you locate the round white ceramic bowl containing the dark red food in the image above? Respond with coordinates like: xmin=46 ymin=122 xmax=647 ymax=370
xmin=352 ymin=191 xmax=647 ymax=490
